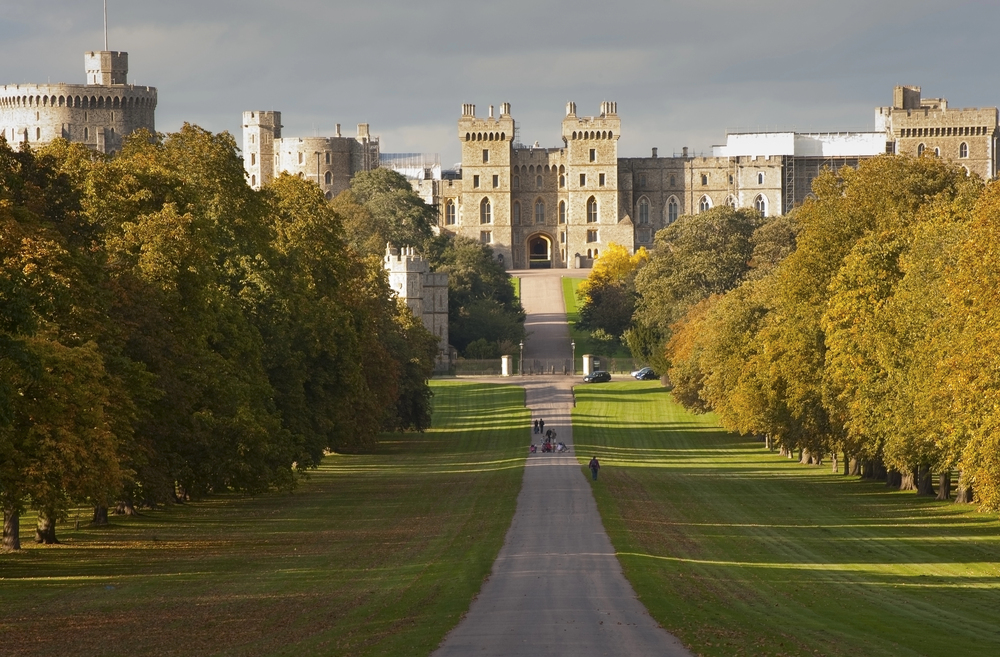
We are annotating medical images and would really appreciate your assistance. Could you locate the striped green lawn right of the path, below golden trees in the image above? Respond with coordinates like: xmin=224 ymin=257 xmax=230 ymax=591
xmin=573 ymin=382 xmax=1000 ymax=657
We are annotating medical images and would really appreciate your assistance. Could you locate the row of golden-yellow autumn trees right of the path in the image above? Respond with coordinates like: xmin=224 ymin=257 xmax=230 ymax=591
xmin=630 ymin=156 xmax=1000 ymax=510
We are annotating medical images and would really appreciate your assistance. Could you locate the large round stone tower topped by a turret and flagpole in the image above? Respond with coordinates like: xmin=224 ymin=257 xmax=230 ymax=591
xmin=0 ymin=50 xmax=156 ymax=153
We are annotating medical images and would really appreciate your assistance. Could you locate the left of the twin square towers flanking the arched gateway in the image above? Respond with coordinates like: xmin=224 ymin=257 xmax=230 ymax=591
xmin=457 ymin=103 xmax=514 ymax=263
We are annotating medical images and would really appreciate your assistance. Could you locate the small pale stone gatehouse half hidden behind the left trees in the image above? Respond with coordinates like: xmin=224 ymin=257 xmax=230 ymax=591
xmin=383 ymin=244 xmax=450 ymax=370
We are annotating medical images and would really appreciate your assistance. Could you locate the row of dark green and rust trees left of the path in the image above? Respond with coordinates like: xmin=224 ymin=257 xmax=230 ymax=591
xmin=0 ymin=126 xmax=437 ymax=548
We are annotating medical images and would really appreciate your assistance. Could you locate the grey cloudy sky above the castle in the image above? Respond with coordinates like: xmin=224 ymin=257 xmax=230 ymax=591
xmin=0 ymin=0 xmax=1000 ymax=166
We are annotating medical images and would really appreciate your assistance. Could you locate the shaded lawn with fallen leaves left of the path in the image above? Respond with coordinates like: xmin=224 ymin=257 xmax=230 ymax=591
xmin=0 ymin=381 xmax=529 ymax=657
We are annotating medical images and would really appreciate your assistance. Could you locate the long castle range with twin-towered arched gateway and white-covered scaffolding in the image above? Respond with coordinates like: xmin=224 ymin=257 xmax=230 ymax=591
xmin=426 ymin=87 xmax=998 ymax=269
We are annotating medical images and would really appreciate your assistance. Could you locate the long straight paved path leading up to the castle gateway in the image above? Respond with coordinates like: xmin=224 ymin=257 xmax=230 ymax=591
xmin=434 ymin=271 xmax=691 ymax=657
